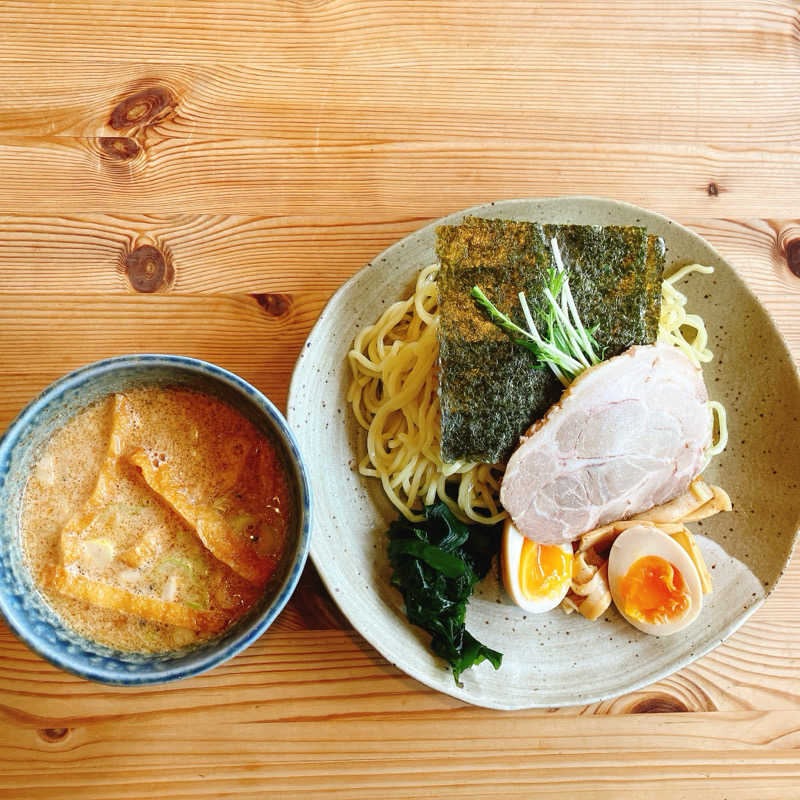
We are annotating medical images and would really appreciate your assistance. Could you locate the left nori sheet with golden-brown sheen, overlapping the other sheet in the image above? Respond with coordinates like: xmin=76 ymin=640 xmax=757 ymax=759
xmin=436 ymin=219 xmax=560 ymax=462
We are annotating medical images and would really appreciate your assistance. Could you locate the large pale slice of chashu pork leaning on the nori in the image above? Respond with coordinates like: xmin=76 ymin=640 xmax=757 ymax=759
xmin=500 ymin=345 xmax=711 ymax=544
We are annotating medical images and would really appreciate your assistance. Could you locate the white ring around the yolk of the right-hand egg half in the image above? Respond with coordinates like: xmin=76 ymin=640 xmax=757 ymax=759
xmin=608 ymin=525 xmax=703 ymax=636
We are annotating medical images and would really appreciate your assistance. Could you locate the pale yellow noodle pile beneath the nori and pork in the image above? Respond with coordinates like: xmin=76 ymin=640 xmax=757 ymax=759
xmin=347 ymin=264 xmax=727 ymax=525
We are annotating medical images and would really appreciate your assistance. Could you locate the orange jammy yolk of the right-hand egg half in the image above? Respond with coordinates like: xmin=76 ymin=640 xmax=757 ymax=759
xmin=619 ymin=556 xmax=691 ymax=624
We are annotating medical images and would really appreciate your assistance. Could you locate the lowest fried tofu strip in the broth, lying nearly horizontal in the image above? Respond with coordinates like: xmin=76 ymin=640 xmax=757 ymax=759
xmin=50 ymin=565 xmax=229 ymax=633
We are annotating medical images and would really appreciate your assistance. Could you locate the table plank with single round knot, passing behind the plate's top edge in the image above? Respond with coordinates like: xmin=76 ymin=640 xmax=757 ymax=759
xmin=0 ymin=216 xmax=800 ymax=296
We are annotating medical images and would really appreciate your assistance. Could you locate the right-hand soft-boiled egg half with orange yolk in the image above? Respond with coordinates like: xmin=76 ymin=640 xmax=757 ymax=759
xmin=608 ymin=525 xmax=703 ymax=636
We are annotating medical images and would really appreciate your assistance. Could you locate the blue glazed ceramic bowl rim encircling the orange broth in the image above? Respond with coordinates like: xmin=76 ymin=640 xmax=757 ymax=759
xmin=0 ymin=353 xmax=313 ymax=686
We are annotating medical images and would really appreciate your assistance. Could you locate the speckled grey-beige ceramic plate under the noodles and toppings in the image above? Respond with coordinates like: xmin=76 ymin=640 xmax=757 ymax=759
xmin=288 ymin=197 xmax=800 ymax=709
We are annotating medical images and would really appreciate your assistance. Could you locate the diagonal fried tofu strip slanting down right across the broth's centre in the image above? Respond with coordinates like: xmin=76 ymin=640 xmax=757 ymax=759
xmin=128 ymin=449 xmax=278 ymax=586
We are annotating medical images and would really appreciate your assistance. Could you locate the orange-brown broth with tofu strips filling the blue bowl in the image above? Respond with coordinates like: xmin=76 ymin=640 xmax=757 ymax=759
xmin=21 ymin=388 xmax=295 ymax=652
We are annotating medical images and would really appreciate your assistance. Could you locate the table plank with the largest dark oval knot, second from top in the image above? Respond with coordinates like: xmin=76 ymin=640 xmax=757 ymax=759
xmin=0 ymin=62 xmax=800 ymax=147
